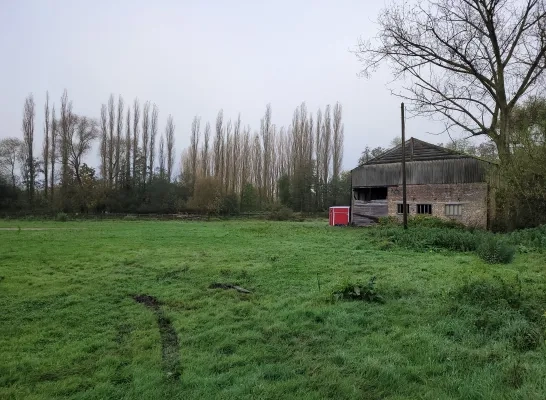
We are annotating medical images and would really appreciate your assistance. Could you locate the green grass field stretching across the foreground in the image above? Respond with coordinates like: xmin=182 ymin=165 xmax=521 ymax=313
xmin=0 ymin=221 xmax=546 ymax=400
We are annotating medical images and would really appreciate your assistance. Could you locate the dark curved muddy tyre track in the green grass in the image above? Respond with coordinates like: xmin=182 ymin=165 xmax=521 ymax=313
xmin=133 ymin=294 xmax=182 ymax=380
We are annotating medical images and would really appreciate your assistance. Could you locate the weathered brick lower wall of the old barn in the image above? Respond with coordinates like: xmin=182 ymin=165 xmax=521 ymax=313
xmin=387 ymin=182 xmax=487 ymax=228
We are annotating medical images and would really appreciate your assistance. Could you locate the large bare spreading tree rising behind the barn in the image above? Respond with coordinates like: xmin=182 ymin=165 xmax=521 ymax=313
xmin=356 ymin=0 xmax=546 ymax=163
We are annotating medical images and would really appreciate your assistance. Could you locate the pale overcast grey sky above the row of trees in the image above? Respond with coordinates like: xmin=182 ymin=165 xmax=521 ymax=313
xmin=0 ymin=0 xmax=447 ymax=169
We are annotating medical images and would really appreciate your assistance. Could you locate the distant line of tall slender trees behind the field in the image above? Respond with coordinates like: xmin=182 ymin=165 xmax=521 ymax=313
xmin=0 ymin=91 xmax=350 ymax=213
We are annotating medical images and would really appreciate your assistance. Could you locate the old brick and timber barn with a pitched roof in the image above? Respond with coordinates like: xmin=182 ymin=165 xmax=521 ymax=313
xmin=351 ymin=138 xmax=494 ymax=228
